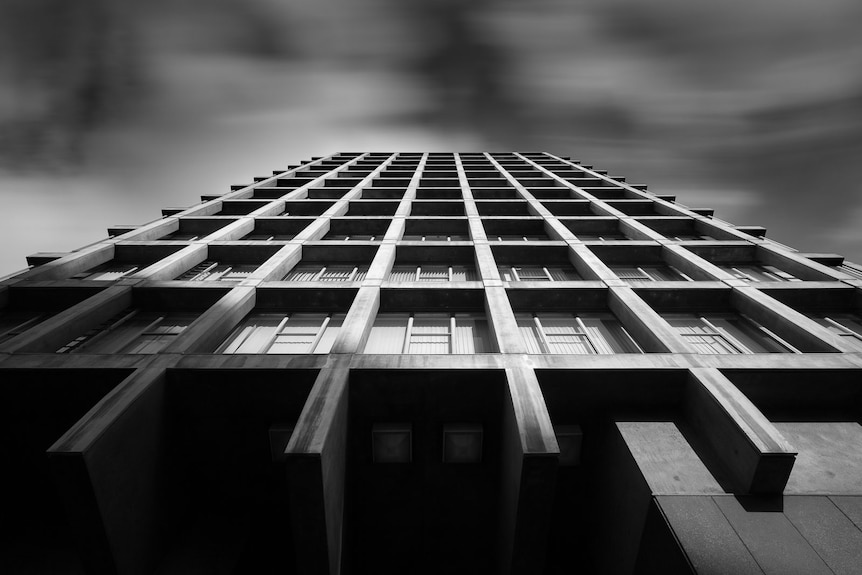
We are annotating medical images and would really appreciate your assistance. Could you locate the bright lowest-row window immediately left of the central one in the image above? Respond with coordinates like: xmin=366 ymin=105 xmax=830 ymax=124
xmin=216 ymin=313 xmax=344 ymax=354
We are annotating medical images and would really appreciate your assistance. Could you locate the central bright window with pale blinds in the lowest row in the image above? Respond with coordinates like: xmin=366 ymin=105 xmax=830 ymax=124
xmin=364 ymin=313 xmax=493 ymax=354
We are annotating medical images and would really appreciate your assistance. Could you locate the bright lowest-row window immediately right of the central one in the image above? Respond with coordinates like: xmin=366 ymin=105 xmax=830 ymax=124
xmin=515 ymin=313 xmax=643 ymax=354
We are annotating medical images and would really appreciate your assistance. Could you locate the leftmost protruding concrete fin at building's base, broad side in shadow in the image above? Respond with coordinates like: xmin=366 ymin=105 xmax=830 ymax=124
xmin=48 ymin=358 xmax=174 ymax=575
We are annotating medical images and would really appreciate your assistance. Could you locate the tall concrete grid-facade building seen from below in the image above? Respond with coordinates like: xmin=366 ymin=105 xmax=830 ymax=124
xmin=0 ymin=153 xmax=862 ymax=575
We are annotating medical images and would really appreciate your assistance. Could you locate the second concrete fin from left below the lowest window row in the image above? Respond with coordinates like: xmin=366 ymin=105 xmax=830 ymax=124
xmin=285 ymin=357 xmax=350 ymax=575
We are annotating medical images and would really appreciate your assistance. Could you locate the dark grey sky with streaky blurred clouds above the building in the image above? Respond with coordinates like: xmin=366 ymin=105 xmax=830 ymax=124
xmin=0 ymin=0 xmax=862 ymax=276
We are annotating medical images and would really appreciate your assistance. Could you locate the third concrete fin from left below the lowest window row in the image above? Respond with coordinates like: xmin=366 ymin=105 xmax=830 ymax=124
xmin=500 ymin=368 xmax=560 ymax=575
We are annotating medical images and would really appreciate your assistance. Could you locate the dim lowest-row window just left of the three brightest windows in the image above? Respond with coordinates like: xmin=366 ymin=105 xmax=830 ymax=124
xmin=57 ymin=310 xmax=197 ymax=354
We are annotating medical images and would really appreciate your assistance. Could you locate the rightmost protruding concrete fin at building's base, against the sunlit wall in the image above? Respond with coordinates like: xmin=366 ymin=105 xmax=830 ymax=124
xmin=685 ymin=368 xmax=796 ymax=493
